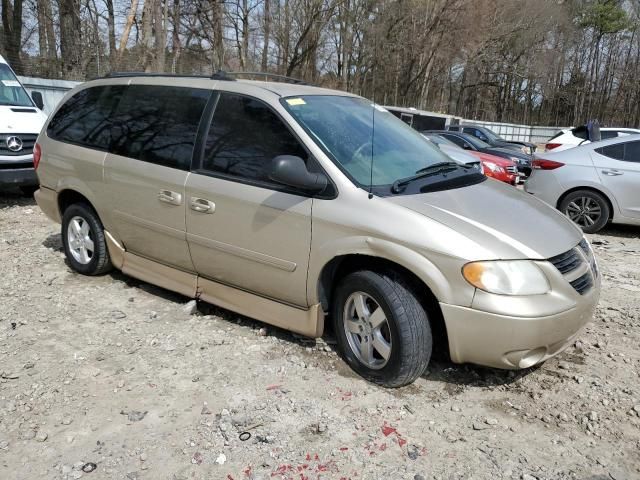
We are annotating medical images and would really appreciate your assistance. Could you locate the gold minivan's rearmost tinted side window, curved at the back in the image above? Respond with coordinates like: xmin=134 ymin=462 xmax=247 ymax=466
xmin=47 ymin=85 xmax=125 ymax=150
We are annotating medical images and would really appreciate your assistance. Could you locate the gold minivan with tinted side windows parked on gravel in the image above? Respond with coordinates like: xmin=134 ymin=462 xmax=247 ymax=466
xmin=34 ymin=73 xmax=600 ymax=387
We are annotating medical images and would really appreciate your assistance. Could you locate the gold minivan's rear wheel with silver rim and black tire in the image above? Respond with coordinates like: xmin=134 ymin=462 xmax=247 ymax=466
xmin=62 ymin=203 xmax=112 ymax=275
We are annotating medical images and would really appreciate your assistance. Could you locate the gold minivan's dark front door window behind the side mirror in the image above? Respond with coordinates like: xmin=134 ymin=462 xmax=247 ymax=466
xmin=202 ymin=93 xmax=308 ymax=183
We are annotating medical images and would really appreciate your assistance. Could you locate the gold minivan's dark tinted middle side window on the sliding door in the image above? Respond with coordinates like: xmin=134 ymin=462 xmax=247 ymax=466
xmin=110 ymin=85 xmax=211 ymax=170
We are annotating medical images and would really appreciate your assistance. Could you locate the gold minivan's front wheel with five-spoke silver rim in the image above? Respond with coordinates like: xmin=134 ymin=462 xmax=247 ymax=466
xmin=332 ymin=270 xmax=433 ymax=387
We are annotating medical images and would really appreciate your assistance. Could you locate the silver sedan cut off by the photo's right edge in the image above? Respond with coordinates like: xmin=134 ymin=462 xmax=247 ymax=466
xmin=525 ymin=135 xmax=640 ymax=233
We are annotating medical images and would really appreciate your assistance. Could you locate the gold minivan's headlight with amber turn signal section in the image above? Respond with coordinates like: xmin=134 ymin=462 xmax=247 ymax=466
xmin=462 ymin=260 xmax=550 ymax=295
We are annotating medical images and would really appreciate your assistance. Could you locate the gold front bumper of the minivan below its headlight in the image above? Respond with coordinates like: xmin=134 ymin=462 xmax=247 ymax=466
xmin=440 ymin=281 xmax=600 ymax=369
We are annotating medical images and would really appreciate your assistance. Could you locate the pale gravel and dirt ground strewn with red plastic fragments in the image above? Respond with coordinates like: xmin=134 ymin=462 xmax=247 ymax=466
xmin=0 ymin=194 xmax=640 ymax=480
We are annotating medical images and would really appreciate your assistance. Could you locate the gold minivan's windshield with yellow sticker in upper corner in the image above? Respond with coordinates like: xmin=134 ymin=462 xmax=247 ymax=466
xmin=281 ymin=95 xmax=465 ymax=189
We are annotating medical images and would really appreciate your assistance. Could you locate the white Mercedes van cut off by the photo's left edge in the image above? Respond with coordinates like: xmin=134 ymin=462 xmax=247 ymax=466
xmin=0 ymin=56 xmax=47 ymax=191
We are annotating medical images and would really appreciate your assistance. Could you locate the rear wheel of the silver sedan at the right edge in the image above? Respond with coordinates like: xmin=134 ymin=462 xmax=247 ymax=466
xmin=560 ymin=190 xmax=611 ymax=233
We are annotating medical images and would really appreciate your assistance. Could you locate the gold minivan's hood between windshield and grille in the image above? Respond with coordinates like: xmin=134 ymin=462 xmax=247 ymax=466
xmin=387 ymin=179 xmax=582 ymax=260
